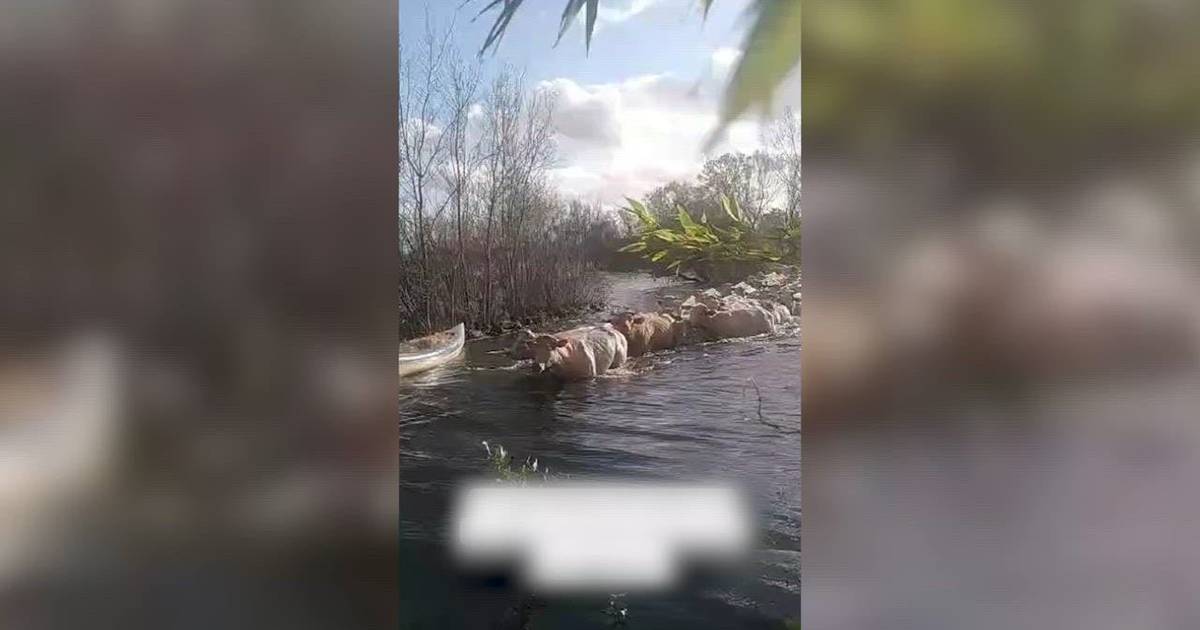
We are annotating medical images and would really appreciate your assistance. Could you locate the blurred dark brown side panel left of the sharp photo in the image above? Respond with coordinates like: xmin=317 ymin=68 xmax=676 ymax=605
xmin=0 ymin=0 xmax=397 ymax=629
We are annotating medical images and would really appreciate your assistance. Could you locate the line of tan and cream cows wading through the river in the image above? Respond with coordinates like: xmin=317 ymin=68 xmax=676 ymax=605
xmin=510 ymin=294 xmax=792 ymax=380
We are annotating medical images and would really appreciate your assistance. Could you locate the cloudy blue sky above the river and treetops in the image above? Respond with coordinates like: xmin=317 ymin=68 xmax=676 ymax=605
xmin=400 ymin=0 xmax=782 ymax=205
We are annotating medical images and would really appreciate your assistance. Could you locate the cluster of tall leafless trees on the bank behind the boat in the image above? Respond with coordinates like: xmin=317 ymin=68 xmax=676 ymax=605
xmin=400 ymin=33 xmax=605 ymax=334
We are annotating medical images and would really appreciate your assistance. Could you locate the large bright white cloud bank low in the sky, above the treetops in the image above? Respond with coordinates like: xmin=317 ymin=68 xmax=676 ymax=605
xmin=539 ymin=65 xmax=760 ymax=204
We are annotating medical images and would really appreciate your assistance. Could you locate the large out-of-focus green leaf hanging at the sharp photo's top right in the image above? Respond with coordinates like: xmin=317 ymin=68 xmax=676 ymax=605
xmin=704 ymin=0 xmax=800 ymax=152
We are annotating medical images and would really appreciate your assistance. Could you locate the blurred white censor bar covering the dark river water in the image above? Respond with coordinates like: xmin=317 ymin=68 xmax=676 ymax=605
xmin=451 ymin=481 xmax=754 ymax=593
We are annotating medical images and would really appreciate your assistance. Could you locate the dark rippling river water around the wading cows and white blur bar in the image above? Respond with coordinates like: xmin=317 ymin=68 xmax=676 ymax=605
xmin=400 ymin=275 xmax=800 ymax=629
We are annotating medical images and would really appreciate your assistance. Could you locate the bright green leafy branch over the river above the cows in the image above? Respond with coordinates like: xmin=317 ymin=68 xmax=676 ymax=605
xmin=620 ymin=197 xmax=781 ymax=272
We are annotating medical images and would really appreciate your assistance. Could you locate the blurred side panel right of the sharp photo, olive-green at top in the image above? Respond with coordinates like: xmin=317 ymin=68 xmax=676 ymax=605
xmin=803 ymin=0 xmax=1200 ymax=630
